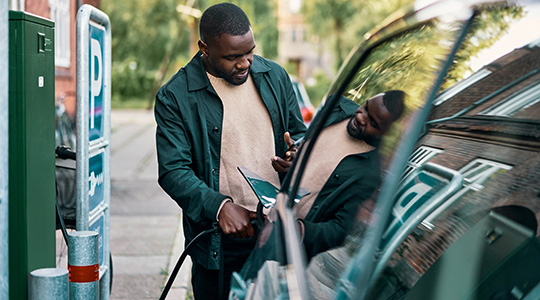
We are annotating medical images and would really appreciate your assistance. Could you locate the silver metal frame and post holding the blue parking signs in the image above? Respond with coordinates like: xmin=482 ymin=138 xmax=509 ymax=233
xmin=77 ymin=4 xmax=112 ymax=300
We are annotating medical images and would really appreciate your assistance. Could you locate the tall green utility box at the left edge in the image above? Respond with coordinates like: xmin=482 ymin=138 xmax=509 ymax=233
xmin=9 ymin=11 xmax=56 ymax=299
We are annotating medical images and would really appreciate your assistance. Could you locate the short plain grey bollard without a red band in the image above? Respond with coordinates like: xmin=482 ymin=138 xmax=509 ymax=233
xmin=28 ymin=268 xmax=69 ymax=300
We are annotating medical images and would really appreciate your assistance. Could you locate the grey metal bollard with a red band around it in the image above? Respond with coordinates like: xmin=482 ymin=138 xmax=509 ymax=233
xmin=68 ymin=231 xmax=99 ymax=300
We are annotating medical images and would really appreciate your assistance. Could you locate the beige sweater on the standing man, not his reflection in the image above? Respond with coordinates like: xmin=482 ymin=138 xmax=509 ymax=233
xmin=207 ymin=73 xmax=279 ymax=211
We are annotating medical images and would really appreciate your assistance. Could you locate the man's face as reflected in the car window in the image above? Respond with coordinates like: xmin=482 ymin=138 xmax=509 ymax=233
xmin=347 ymin=94 xmax=392 ymax=145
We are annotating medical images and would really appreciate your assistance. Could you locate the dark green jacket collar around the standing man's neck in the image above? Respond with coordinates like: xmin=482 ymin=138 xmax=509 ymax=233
xmin=185 ymin=51 xmax=271 ymax=92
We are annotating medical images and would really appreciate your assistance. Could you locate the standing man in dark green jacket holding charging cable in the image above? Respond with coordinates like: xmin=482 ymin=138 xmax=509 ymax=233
xmin=155 ymin=3 xmax=306 ymax=299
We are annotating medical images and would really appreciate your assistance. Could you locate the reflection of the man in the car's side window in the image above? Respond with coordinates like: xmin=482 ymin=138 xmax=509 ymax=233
xmin=276 ymin=90 xmax=405 ymax=258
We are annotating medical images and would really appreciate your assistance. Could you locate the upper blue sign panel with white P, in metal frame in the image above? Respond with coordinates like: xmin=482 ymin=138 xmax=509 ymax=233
xmin=88 ymin=22 xmax=105 ymax=142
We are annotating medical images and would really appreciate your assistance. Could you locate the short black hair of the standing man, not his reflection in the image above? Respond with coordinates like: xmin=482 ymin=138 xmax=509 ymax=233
xmin=199 ymin=2 xmax=251 ymax=44
